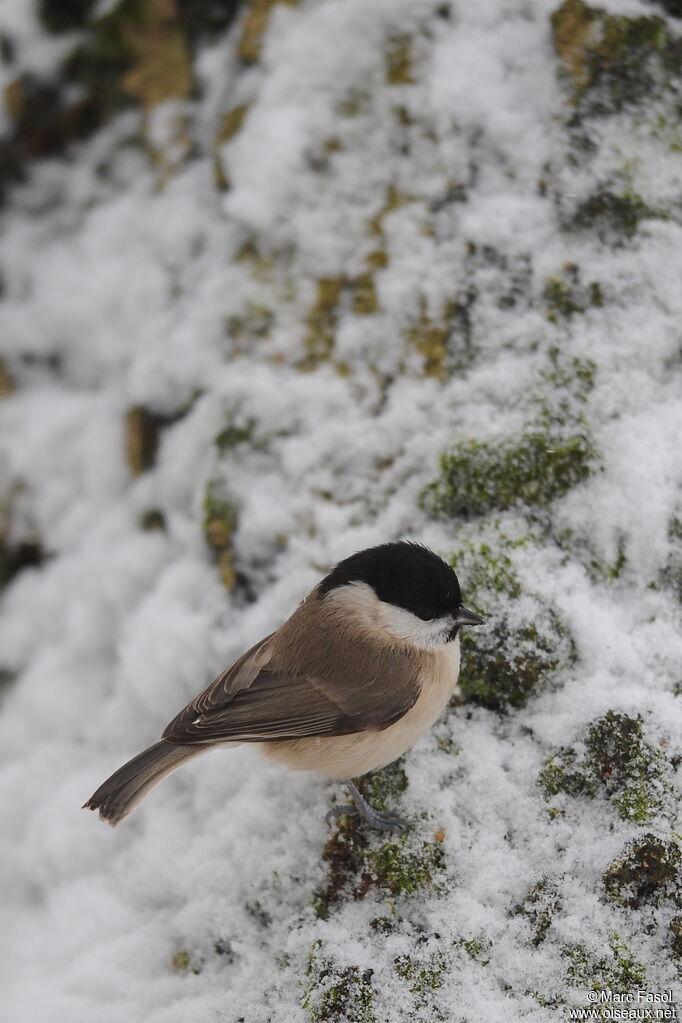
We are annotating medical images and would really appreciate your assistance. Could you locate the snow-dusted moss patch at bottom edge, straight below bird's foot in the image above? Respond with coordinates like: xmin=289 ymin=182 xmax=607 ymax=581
xmin=303 ymin=940 xmax=376 ymax=1023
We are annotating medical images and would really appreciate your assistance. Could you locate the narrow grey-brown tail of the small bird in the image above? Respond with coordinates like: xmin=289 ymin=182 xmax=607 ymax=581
xmin=83 ymin=741 xmax=206 ymax=827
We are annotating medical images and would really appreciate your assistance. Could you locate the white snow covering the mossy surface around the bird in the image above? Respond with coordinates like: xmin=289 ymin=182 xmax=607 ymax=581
xmin=0 ymin=0 xmax=682 ymax=1023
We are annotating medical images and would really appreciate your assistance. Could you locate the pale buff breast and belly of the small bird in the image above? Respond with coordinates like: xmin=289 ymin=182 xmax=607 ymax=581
xmin=259 ymin=639 xmax=459 ymax=779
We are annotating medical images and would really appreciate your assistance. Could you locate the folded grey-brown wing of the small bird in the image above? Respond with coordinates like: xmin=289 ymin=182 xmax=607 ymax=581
xmin=163 ymin=601 xmax=418 ymax=745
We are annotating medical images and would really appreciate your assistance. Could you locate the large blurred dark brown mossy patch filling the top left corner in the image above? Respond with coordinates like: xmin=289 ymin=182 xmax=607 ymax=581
xmin=0 ymin=0 xmax=237 ymax=182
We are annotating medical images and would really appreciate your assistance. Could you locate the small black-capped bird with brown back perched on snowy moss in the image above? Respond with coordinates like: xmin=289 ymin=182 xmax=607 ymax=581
xmin=85 ymin=540 xmax=484 ymax=829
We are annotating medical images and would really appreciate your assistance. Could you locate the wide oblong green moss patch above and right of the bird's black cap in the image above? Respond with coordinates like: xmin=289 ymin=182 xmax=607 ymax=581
xmin=421 ymin=427 xmax=595 ymax=519
